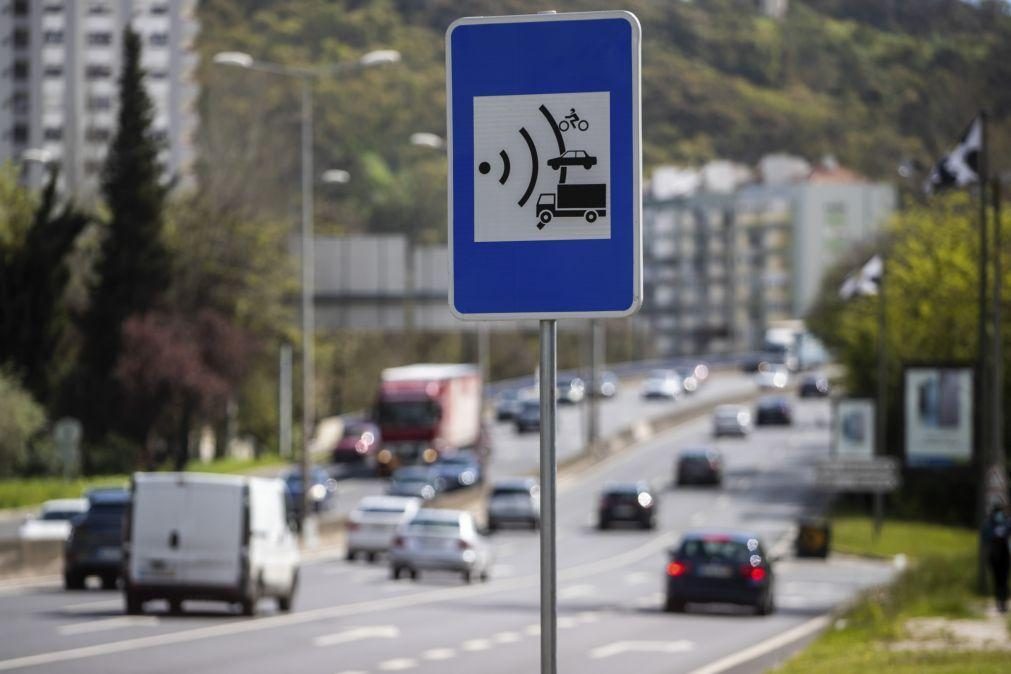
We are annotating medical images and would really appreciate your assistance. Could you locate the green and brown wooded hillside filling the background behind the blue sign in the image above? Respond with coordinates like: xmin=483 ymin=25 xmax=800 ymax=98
xmin=198 ymin=0 xmax=1011 ymax=240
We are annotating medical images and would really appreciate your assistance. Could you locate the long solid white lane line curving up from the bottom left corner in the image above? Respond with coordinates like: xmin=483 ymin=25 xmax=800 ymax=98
xmin=0 ymin=521 xmax=677 ymax=671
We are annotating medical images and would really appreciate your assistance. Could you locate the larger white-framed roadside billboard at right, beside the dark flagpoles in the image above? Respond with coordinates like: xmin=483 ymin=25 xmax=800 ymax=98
xmin=905 ymin=366 xmax=975 ymax=468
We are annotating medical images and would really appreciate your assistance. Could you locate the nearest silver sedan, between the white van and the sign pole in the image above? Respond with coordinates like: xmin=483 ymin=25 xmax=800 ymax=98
xmin=389 ymin=508 xmax=492 ymax=583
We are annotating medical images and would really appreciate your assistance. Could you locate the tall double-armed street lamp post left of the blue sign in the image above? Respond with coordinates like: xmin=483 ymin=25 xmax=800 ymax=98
xmin=213 ymin=50 xmax=400 ymax=541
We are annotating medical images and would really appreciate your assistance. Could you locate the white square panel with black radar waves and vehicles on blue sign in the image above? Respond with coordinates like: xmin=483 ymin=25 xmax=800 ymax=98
xmin=473 ymin=91 xmax=611 ymax=242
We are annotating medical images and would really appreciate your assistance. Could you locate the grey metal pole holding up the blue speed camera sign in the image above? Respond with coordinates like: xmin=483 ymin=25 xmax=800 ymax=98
xmin=540 ymin=320 xmax=558 ymax=674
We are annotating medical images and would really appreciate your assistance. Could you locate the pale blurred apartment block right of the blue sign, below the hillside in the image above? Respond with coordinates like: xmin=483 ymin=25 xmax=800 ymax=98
xmin=638 ymin=156 xmax=895 ymax=356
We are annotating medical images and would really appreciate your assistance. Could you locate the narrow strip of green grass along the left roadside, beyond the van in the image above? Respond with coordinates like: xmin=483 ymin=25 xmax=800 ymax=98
xmin=0 ymin=455 xmax=285 ymax=508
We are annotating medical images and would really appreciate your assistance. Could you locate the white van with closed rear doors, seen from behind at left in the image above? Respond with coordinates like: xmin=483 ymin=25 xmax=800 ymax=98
xmin=123 ymin=473 xmax=299 ymax=615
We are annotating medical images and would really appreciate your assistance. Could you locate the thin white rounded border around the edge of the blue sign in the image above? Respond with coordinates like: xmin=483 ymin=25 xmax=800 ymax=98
xmin=446 ymin=10 xmax=643 ymax=321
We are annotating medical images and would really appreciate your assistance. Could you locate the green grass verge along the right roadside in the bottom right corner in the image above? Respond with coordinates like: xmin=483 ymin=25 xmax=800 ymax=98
xmin=775 ymin=517 xmax=1011 ymax=674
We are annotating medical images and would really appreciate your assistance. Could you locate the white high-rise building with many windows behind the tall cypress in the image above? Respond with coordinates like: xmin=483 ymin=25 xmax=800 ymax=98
xmin=0 ymin=0 xmax=199 ymax=200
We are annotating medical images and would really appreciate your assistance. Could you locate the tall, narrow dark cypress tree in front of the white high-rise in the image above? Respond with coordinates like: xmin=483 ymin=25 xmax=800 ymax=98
xmin=71 ymin=26 xmax=171 ymax=448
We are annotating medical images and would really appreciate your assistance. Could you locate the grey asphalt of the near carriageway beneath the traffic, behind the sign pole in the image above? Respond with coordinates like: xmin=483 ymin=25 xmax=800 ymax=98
xmin=0 ymin=401 xmax=891 ymax=674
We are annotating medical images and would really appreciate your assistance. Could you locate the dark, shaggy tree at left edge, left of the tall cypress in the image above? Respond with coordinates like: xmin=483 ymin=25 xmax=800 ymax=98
xmin=0 ymin=171 xmax=91 ymax=403
